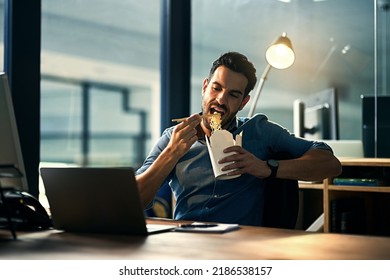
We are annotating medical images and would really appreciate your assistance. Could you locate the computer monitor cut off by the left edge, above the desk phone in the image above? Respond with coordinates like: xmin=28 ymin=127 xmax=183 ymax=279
xmin=0 ymin=73 xmax=28 ymax=191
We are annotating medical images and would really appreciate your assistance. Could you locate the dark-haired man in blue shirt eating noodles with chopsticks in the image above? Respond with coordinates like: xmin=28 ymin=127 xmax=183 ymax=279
xmin=136 ymin=52 xmax=341 ymax=225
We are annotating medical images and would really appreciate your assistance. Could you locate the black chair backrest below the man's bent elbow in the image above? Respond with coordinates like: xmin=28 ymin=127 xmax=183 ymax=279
xmin=263 ymin=179 xmax=299 ymax=229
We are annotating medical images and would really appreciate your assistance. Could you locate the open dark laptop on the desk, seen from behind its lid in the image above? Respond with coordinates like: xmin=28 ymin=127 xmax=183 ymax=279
xmin=40 ymin=167 xmax=174 ymax=235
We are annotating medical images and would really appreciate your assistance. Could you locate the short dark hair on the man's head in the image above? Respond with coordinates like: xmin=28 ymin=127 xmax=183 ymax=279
xmin=209 ymin=52 xmax=257 ymax=97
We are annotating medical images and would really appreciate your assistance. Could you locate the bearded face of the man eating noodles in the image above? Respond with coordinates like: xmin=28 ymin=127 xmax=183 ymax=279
xmin=202 ymin=66 xmax=250 ymax=130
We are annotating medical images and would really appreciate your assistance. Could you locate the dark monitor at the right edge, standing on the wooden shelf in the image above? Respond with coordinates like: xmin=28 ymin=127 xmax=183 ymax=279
xmin=361 ymin=95 xmax=390 ymax=158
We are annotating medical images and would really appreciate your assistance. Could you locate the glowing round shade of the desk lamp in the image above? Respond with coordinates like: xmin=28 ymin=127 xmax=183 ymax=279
xmin=265 ymin=33 xmax=295 ymax=69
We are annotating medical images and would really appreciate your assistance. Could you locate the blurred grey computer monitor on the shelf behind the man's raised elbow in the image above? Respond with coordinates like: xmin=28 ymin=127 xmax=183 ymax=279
xmin=293 ymin=88 xmax=339 ymax=140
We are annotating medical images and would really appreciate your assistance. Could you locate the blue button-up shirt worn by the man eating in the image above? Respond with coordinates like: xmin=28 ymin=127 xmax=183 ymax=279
xmin=136 ymin=114 xmax=331 ymax=225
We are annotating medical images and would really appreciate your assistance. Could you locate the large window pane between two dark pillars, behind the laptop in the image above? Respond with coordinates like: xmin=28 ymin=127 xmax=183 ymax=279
xmin=41 ymin=0 xmax=160 ymax=168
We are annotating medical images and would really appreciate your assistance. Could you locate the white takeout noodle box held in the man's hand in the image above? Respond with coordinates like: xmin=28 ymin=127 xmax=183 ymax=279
xmin=206 ymin=129 xmax=242 ymax=180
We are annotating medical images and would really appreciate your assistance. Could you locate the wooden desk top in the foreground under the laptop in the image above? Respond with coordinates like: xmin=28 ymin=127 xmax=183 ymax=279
xmin=0 ymin=220 xmax=390 ymax=260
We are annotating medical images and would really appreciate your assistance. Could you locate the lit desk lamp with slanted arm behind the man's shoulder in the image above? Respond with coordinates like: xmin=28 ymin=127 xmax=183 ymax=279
xmin=248 ymin=32 xmax=295 ymax=117
